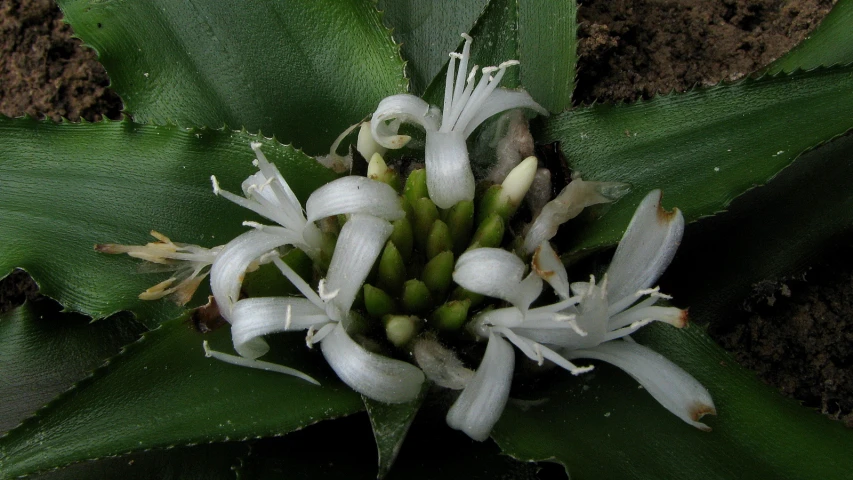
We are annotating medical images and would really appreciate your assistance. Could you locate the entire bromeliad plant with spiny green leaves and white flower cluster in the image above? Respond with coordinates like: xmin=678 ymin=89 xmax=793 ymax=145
xmin=0 ymin=0 xmax=853 ymax=478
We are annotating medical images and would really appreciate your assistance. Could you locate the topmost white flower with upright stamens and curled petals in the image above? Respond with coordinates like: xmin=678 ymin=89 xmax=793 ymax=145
xmin=371 ymin=34 xmax=548 ymax=208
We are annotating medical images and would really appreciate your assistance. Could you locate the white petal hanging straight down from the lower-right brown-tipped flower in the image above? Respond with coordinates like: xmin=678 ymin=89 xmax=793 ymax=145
xmin=447 ymin=334 xmax=515 ymax=442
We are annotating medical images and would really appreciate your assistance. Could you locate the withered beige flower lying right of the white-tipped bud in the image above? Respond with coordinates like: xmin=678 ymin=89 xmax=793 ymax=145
xmin=522 ymin=177 xmax=629 ymax=255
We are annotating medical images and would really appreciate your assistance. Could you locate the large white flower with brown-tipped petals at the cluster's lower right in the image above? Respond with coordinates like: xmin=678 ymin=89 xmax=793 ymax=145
xmin=447 ymin=191 xmax=715 ymax=440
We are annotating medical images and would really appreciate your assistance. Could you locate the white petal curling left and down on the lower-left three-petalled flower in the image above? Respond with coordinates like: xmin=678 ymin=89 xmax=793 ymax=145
xmin=231 ymin=297 xmax=330 ymax=358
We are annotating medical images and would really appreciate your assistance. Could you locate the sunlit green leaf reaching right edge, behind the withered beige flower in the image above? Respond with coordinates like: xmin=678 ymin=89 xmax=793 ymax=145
xmin=537 ymin=67 xmax=853 ymax=252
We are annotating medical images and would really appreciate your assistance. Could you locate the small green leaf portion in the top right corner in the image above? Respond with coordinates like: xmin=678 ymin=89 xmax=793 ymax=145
xmin=767 ymin=0 xmax=853 ymax=74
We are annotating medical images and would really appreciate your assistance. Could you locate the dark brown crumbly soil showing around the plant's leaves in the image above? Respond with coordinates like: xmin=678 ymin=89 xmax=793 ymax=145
xmin=0 ymin=0 xmax=853 ymax=425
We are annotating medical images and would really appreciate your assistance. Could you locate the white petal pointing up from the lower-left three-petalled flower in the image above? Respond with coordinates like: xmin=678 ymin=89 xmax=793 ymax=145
xmin=325 ymin=214 xmax=394 ymax=321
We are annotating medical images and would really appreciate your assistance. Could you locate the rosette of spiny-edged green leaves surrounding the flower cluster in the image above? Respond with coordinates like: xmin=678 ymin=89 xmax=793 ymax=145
xmin=0 ymin=0 xmax=853 ymax=479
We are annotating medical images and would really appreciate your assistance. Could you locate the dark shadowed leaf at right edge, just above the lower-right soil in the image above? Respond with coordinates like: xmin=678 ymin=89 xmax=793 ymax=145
xmin=664 ymin=136 xmax=853 ymax=316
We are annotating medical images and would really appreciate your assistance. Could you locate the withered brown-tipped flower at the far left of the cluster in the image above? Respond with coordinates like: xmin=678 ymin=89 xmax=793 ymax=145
xmin=95 ymin=230 xmax=222 ymax=305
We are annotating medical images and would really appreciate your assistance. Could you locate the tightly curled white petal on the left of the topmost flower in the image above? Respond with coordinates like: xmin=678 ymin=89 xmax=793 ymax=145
xmin=370 ymin=94 xmax=441 ymax=149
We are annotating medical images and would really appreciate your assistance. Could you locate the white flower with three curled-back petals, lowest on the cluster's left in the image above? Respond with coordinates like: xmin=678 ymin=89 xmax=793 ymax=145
xmin=216 ymin=214 xmax=424 ymax=403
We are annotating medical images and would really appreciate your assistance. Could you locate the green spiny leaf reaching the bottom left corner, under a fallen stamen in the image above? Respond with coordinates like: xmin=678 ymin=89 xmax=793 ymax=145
xmin=0 ymin=316 xmax=363 ymax=478
